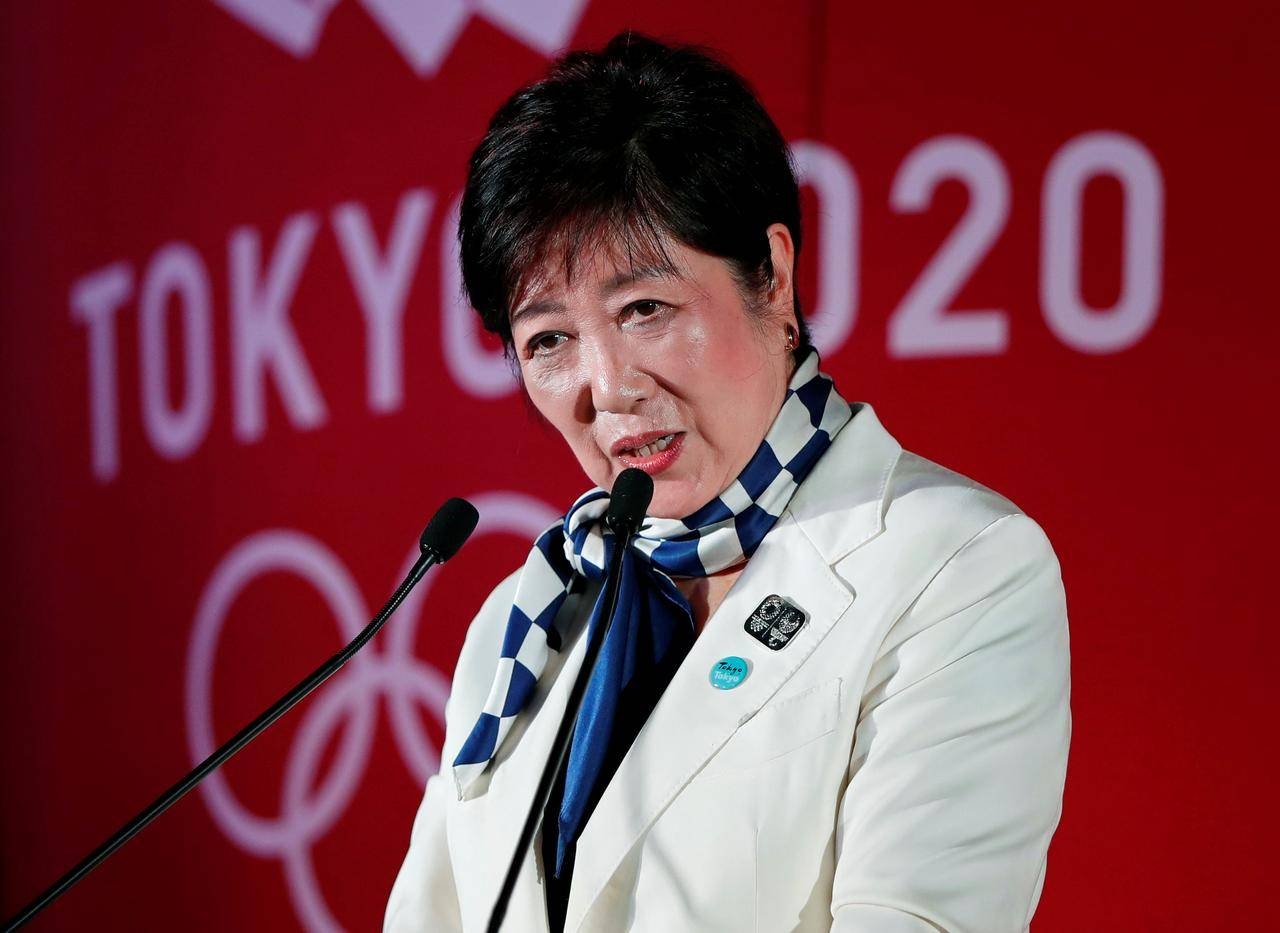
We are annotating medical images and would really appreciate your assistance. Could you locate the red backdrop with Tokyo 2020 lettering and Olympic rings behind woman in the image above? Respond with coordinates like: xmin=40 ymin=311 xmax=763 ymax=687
xmin=0 ymin=0 xmax=1280 ymax=930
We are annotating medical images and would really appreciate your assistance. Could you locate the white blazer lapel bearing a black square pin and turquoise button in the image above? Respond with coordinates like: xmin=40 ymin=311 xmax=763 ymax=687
xmin=566 ymin=404 xmax=901 ymax=930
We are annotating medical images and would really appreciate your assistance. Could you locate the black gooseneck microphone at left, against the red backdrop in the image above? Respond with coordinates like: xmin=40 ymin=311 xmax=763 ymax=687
xmin=4 ymin=499 xmax=480 ymax=933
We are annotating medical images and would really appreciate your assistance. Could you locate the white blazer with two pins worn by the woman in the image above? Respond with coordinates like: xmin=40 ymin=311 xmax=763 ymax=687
xmin=385 ymin=404 xmax=1070 ymax=933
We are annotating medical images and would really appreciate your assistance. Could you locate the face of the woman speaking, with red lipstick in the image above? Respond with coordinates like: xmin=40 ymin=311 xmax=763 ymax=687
xmin=511 ymin=224 xmax=795 ymax=518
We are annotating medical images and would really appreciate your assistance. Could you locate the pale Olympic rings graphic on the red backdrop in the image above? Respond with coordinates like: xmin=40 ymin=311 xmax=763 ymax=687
xmin=186 ymin=491 xmax=557 ymax=932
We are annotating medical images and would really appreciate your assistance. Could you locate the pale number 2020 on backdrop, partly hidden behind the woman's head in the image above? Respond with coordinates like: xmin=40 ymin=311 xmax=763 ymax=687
xmin=792 ymin=132 xmax=1165 ymax=358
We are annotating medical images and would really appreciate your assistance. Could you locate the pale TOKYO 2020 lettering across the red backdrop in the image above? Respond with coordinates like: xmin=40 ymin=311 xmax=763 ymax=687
xmin=69 ymin=133 xmax=1165 ymax=481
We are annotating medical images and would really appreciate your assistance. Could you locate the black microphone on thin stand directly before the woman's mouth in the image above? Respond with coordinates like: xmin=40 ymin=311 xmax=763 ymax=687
xmin=488 ymin=467 xmax=653 ymax=933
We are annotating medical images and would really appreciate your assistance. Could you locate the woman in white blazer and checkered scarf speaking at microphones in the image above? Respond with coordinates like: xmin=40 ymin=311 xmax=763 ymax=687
xmin=387 ymin=35 xmax=1069 ymax=933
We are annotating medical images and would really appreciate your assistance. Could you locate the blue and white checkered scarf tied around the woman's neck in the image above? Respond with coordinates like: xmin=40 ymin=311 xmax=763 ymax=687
xmin=453 ymin=349 xmax=852 ymax=873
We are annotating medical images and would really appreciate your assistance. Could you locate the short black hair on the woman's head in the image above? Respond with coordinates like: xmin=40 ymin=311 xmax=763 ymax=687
xmin=458 ymin=32 xmax=809 ymax=353
